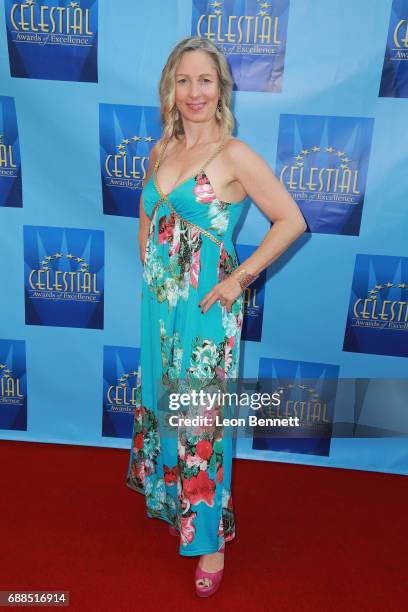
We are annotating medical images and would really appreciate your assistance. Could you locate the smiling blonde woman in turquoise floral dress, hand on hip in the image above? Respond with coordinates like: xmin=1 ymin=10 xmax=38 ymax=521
xmin=127 ymin=37 xmax=306 ymax=597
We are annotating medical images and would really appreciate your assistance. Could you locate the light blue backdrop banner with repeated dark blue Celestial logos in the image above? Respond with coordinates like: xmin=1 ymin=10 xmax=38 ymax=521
xmin=0 ymin=0 xmax=408 ymax=477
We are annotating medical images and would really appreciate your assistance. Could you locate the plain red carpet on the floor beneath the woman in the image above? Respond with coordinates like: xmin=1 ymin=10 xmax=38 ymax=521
xmin=0 ymin=442 xmax=408 ymax=612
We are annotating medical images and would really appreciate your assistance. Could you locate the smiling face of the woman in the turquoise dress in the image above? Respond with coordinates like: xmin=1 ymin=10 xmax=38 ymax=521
xmin=175 ymin=49 xmax=220 ymax=122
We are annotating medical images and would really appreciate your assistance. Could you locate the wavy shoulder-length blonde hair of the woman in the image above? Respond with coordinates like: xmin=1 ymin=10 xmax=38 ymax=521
xmin=159 ymin=36 xmax=235 ymax=140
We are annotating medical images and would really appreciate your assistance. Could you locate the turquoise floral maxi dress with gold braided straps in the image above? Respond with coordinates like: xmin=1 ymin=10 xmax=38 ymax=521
xmin=126 ymin=136 xmax=249 ymax=556
